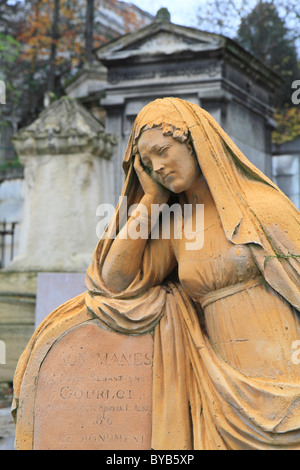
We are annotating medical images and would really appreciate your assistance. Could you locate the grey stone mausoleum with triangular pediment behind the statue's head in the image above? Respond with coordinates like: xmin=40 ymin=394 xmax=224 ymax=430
xmin=67 ymin=8 xmax=281 ymax=202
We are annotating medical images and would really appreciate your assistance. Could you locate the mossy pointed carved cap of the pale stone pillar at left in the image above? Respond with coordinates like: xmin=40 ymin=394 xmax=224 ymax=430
xmin=13 ymin=97 xmax=117 ymax=161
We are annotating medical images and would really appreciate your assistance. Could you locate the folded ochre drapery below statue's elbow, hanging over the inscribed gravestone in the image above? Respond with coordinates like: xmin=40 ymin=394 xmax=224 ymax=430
xmin=13 ymin=283 xmax=300 ymax=450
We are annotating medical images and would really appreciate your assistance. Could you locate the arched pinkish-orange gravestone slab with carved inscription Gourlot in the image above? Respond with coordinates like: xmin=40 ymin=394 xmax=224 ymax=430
xmin=33 ymin=320 xmax=153 ymax=450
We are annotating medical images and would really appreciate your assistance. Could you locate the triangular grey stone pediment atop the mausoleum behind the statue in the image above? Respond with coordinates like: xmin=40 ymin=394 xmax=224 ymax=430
xmin=97 ymin=23 xmax=224 ymax=62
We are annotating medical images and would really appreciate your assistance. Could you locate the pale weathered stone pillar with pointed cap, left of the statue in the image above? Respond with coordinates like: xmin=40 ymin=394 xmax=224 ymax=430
xmin=8 ymin=98 xmax=115 ymax=272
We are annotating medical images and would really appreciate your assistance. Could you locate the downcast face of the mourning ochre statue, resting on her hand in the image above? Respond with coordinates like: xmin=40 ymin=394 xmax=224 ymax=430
xmin=138 ymin=128 xmax=200 ymax=193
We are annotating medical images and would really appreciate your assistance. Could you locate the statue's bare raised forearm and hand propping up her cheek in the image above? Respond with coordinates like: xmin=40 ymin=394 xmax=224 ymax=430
xmin=102 ymin=155 xmax=170 ymax=292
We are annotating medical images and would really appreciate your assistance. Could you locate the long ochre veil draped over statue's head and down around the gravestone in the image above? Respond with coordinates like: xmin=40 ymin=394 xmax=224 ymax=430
xmin=13 ymin=98 xmax=300 ymax=449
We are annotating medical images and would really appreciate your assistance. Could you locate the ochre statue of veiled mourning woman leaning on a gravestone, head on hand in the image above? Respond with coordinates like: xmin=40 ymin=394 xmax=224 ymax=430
xmin=13 ymin=98 xmax=300 ymax=450
